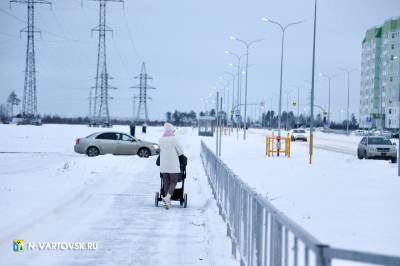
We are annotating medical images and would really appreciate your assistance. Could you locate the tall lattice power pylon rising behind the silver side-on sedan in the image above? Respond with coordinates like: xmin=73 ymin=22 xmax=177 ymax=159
xmin=91 ymin=0 xmax=123 ymax=127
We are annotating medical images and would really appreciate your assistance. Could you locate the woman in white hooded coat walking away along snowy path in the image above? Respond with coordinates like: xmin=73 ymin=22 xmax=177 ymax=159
xmin=158 ymin=123 xmax=183 ymax=209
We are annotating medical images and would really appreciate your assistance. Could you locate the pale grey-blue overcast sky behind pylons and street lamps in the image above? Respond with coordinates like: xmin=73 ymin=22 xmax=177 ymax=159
xmin=0 ymin=0 xmax=400 ymax=119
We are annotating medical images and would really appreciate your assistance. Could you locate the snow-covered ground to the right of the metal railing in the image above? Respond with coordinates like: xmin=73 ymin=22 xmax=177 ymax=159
xmin=206 ymin=129 xmax=400 ymax=255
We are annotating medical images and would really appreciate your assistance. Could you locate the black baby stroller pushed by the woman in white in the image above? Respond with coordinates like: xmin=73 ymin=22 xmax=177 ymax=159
xmin=154 ymin=155 xmax=187 ymax=208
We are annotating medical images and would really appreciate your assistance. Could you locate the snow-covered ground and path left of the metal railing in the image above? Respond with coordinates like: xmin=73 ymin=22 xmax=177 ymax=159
xmin=0 ymin=125 xmax=238 ymax=265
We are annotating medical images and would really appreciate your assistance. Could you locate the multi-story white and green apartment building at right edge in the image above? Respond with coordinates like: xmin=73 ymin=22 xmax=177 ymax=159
xmin=360 ymin=18 xmax=400 ymax=128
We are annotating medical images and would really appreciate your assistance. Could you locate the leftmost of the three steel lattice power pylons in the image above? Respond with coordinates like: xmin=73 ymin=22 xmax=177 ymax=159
xmin=10 ymin=0 xmax=51 ymax=119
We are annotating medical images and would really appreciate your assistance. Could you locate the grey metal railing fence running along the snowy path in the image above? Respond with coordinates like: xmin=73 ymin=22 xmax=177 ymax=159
xmin=201 ymin=142 xmax=400 ymax=266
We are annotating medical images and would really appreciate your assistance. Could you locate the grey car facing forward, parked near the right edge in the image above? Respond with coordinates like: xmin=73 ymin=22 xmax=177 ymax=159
xmin=357 ymin=136 xmax=397 ymax=163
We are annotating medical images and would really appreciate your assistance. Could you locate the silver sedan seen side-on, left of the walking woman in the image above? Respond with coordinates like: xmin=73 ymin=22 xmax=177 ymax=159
xmin=74 ymin=132 xmax=160 ymax=158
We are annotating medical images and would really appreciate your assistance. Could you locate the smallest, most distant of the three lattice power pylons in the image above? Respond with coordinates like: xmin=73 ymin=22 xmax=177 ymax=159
xmin=131 ymin=62 xmax=156 ymax=123
